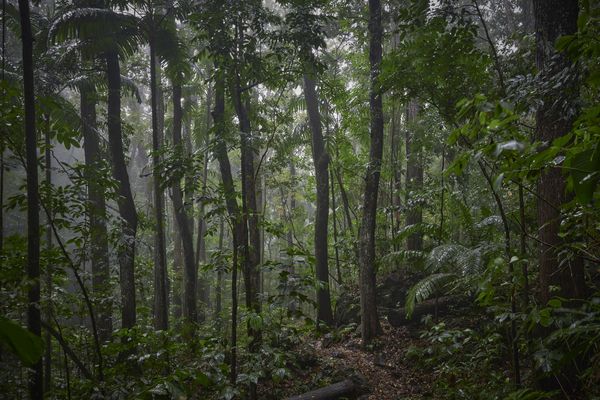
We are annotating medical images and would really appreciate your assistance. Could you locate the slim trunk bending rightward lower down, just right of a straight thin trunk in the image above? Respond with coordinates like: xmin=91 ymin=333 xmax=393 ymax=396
xmin=173 ymin=77 xmax=198 ymax=323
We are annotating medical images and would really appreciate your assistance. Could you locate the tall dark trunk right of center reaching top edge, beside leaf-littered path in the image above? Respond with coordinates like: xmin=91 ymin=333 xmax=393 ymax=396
xmin=358 ymin=0 xmax=383 ymax=346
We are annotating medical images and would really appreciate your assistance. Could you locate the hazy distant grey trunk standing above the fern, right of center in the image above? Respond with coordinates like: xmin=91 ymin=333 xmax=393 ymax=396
xmin=406 ymin=99 xmax=423 ymax=251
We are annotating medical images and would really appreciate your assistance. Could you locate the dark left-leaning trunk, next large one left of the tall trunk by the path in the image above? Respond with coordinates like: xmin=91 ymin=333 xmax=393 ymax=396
xmin=304 ymin=70 xmax=333 ymax=326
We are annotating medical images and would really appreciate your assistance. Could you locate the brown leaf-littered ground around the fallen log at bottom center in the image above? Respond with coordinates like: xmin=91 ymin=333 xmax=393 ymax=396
xmin=263 ymin=320 xmax=433 ymax=400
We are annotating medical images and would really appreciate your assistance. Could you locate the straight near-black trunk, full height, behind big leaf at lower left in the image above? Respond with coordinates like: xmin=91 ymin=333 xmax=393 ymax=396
xmin=19 ymin=0 xmax=44 ymax=400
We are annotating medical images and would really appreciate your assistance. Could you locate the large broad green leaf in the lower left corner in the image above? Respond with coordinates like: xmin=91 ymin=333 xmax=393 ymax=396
xmin=0 ymin=317 xmax=43 ymax=366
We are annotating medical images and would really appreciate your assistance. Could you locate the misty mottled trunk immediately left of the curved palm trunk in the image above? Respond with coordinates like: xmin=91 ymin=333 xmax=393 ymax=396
xmin=80 ymin=85 xmax=113 ymax=342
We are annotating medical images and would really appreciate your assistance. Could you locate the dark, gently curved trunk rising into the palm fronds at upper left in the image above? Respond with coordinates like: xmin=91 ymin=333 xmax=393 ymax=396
xmin=106 ymin=50 xmax=138 ymax=328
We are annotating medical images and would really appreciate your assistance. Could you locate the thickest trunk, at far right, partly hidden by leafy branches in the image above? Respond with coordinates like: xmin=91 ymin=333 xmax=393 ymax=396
xmin=533 ymin=0 xmax=585 ymax=304
